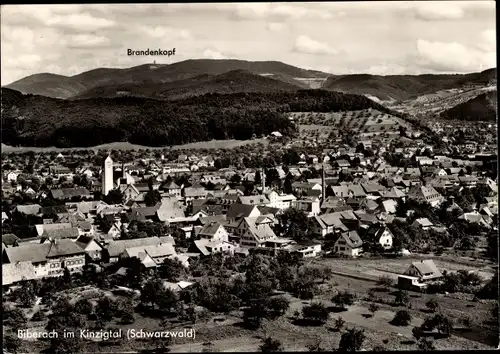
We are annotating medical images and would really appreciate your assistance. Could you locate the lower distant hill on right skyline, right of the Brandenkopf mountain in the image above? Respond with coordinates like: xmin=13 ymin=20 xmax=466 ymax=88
xmin=323 ymin=69 xmax=496 ymax=101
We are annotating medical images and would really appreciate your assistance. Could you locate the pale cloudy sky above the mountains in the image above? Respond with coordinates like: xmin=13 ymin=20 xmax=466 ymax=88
xmin=1 ymin=1 xmax=496 ymax=85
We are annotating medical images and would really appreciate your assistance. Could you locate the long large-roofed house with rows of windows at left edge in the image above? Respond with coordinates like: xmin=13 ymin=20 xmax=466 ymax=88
xmin=3 ymin=239 xmax=85 ymax=278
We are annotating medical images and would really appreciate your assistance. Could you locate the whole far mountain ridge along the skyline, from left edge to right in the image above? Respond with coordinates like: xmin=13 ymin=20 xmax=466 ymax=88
xmin=4 ymin=59 xmax=496 ymax=101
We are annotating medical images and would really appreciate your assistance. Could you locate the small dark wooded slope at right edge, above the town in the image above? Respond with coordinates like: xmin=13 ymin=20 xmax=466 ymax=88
xmin=440 ymin=90 xmax=497 ymax=122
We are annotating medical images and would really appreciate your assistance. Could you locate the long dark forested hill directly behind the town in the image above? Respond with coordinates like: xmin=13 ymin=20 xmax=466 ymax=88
xmin=2 ymin=88 xmax=393 ymax=148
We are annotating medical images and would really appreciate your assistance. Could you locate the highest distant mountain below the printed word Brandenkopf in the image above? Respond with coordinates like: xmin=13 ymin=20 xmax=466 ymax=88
xmin=5 ymin=59 xmax=329 ymax=98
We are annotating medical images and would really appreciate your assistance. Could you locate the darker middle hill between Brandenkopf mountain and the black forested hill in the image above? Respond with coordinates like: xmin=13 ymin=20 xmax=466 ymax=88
xmin=72 ymin=70 xmax=306 ymax=100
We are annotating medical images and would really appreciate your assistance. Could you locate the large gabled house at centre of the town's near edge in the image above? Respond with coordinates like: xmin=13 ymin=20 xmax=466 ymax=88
xmin=240 ymin=216 xmax=276 ymax=247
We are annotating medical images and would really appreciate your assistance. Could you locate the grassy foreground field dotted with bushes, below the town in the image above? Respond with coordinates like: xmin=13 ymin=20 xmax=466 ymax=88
xmin=11 ymin=255 xmax=498 ymax=353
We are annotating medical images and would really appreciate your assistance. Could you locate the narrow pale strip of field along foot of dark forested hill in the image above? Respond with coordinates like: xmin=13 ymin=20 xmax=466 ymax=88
xmin=2 ymin=138 xmax=268 ymax=153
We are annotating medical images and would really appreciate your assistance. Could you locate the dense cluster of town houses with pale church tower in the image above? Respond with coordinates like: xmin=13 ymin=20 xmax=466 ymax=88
xmin=2 ymin=141 xmax=498 ymax=285
